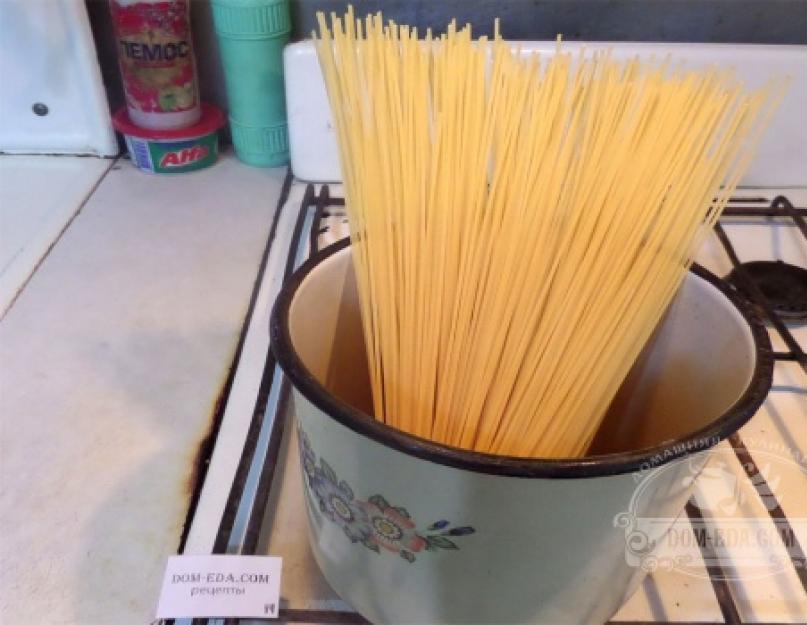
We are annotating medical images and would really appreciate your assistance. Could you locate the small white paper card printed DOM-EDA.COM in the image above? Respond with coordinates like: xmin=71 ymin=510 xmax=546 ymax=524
xmin=157 ymin=555 xmax=282 ymax=619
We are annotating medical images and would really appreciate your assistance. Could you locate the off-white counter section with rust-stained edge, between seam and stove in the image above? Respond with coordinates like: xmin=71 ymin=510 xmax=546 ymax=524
xmin=0 ymin=154 xmax=285 ymax=625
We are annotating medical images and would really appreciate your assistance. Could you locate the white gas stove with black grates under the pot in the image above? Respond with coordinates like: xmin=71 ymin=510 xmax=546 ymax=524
xmin=183 ymin=44 xmax=807 ymax=623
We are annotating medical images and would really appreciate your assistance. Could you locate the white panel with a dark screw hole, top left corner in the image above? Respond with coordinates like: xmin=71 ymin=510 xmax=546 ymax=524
xmin=0 ymin=0 xmax=118 ymax=156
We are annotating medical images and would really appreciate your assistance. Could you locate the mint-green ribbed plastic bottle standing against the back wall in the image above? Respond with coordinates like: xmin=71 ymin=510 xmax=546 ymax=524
xmin=211 ymin=0 xmax=291 ymax=167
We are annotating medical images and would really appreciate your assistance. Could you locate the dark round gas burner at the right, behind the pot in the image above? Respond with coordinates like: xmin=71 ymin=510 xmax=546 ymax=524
xmin=725 ymin=260 xmax=807 ymax=321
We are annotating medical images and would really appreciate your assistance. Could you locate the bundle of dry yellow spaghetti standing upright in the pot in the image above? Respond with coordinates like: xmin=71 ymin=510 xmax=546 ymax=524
xmin=315 ymin=10 xmax=773 ymax=457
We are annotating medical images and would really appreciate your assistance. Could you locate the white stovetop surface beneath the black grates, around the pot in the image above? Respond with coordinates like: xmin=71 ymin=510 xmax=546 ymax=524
xmin=187 ymin=182 xmax=807 ymax=623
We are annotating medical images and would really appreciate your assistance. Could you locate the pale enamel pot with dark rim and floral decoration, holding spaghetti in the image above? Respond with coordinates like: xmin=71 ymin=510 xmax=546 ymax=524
xmin=271 ymin=240 xmax=773 ymax=625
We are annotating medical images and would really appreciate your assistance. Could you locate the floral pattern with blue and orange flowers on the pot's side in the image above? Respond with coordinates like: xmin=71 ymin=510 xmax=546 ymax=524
xmin=297 ymin=427 xmax=476 ymax=562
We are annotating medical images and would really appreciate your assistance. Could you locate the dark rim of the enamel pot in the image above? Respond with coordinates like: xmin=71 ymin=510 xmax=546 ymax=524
xmin=270 ymin=238 xmax=773 ymax=479
